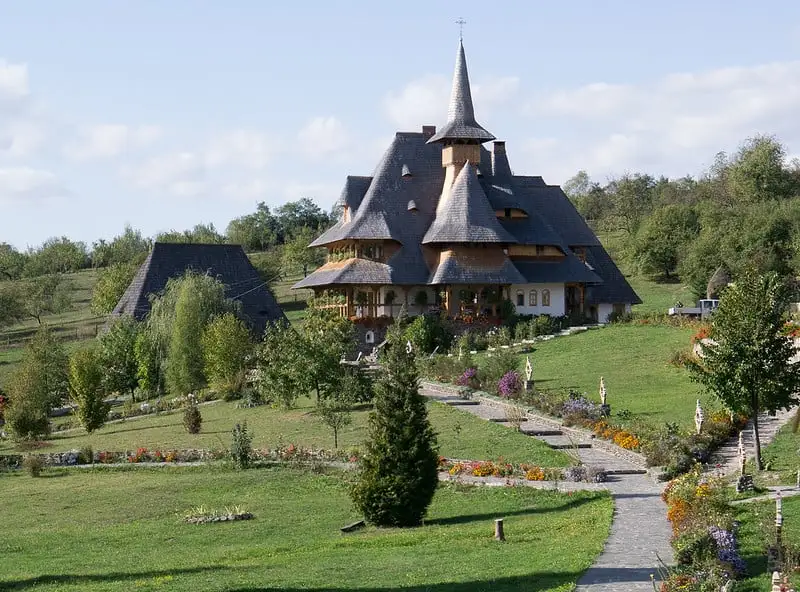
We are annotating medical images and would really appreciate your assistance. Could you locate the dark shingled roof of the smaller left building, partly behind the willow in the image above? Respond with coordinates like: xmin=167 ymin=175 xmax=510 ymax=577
xmin=111 ymin=243 xmax=285 ymax=334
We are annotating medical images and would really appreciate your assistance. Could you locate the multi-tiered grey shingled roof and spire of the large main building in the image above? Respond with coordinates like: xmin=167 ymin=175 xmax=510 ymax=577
xmin=295 ymin=38 xmax=640 ymax=303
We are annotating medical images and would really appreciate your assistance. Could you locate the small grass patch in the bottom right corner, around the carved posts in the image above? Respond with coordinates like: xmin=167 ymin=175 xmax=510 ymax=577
xmin=736 ymin=497 xmax=800 ymax=592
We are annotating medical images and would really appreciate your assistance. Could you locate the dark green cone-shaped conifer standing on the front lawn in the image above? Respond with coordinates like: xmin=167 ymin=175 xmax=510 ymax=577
xmin=351 ymin=331 xmax=438 ymax=526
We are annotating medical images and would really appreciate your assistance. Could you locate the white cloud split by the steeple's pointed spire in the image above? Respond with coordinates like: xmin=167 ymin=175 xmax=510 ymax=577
xmin=383 ymin=76 xmax=520 ymax=131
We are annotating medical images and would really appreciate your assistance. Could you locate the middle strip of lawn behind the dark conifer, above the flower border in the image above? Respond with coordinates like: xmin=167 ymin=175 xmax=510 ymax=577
xmin=0 ymin=398 xmax=571 ymax=467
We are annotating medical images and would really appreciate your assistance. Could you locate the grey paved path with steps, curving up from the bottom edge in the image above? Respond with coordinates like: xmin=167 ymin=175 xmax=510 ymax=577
xmin=420 ymin=385 xmax=672 ymax=592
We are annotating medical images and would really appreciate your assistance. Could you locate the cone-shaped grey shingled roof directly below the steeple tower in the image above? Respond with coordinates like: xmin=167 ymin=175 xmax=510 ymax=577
xmin=422 ymin=162 xmax=517 ymax=244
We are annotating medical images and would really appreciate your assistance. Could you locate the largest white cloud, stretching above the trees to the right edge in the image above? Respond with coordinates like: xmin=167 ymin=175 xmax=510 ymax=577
xmin=526 ymin=61 xmax=800 ymax=181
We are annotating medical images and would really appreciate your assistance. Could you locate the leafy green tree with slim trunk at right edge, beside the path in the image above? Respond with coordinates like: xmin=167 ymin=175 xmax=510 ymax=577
xmin=690 ymin=272 xmax=800 ymax=470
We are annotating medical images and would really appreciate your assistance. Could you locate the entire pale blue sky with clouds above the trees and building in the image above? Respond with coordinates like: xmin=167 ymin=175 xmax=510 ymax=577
xmin=0 ymin=0 xmax=800 ymax=248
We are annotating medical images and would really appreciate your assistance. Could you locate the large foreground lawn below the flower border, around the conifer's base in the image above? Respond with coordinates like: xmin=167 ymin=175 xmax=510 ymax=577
xmin=0 ymin=467 xmax=612 ymax=592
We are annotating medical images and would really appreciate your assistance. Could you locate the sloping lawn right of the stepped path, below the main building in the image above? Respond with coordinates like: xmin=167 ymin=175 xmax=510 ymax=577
xmin=521 ymin=324 xmax=709 ymax=427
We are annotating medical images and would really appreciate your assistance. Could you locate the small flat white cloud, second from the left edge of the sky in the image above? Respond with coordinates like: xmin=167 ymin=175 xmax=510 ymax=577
xmin=64 ymin=124 xmax=161 ymax=161
